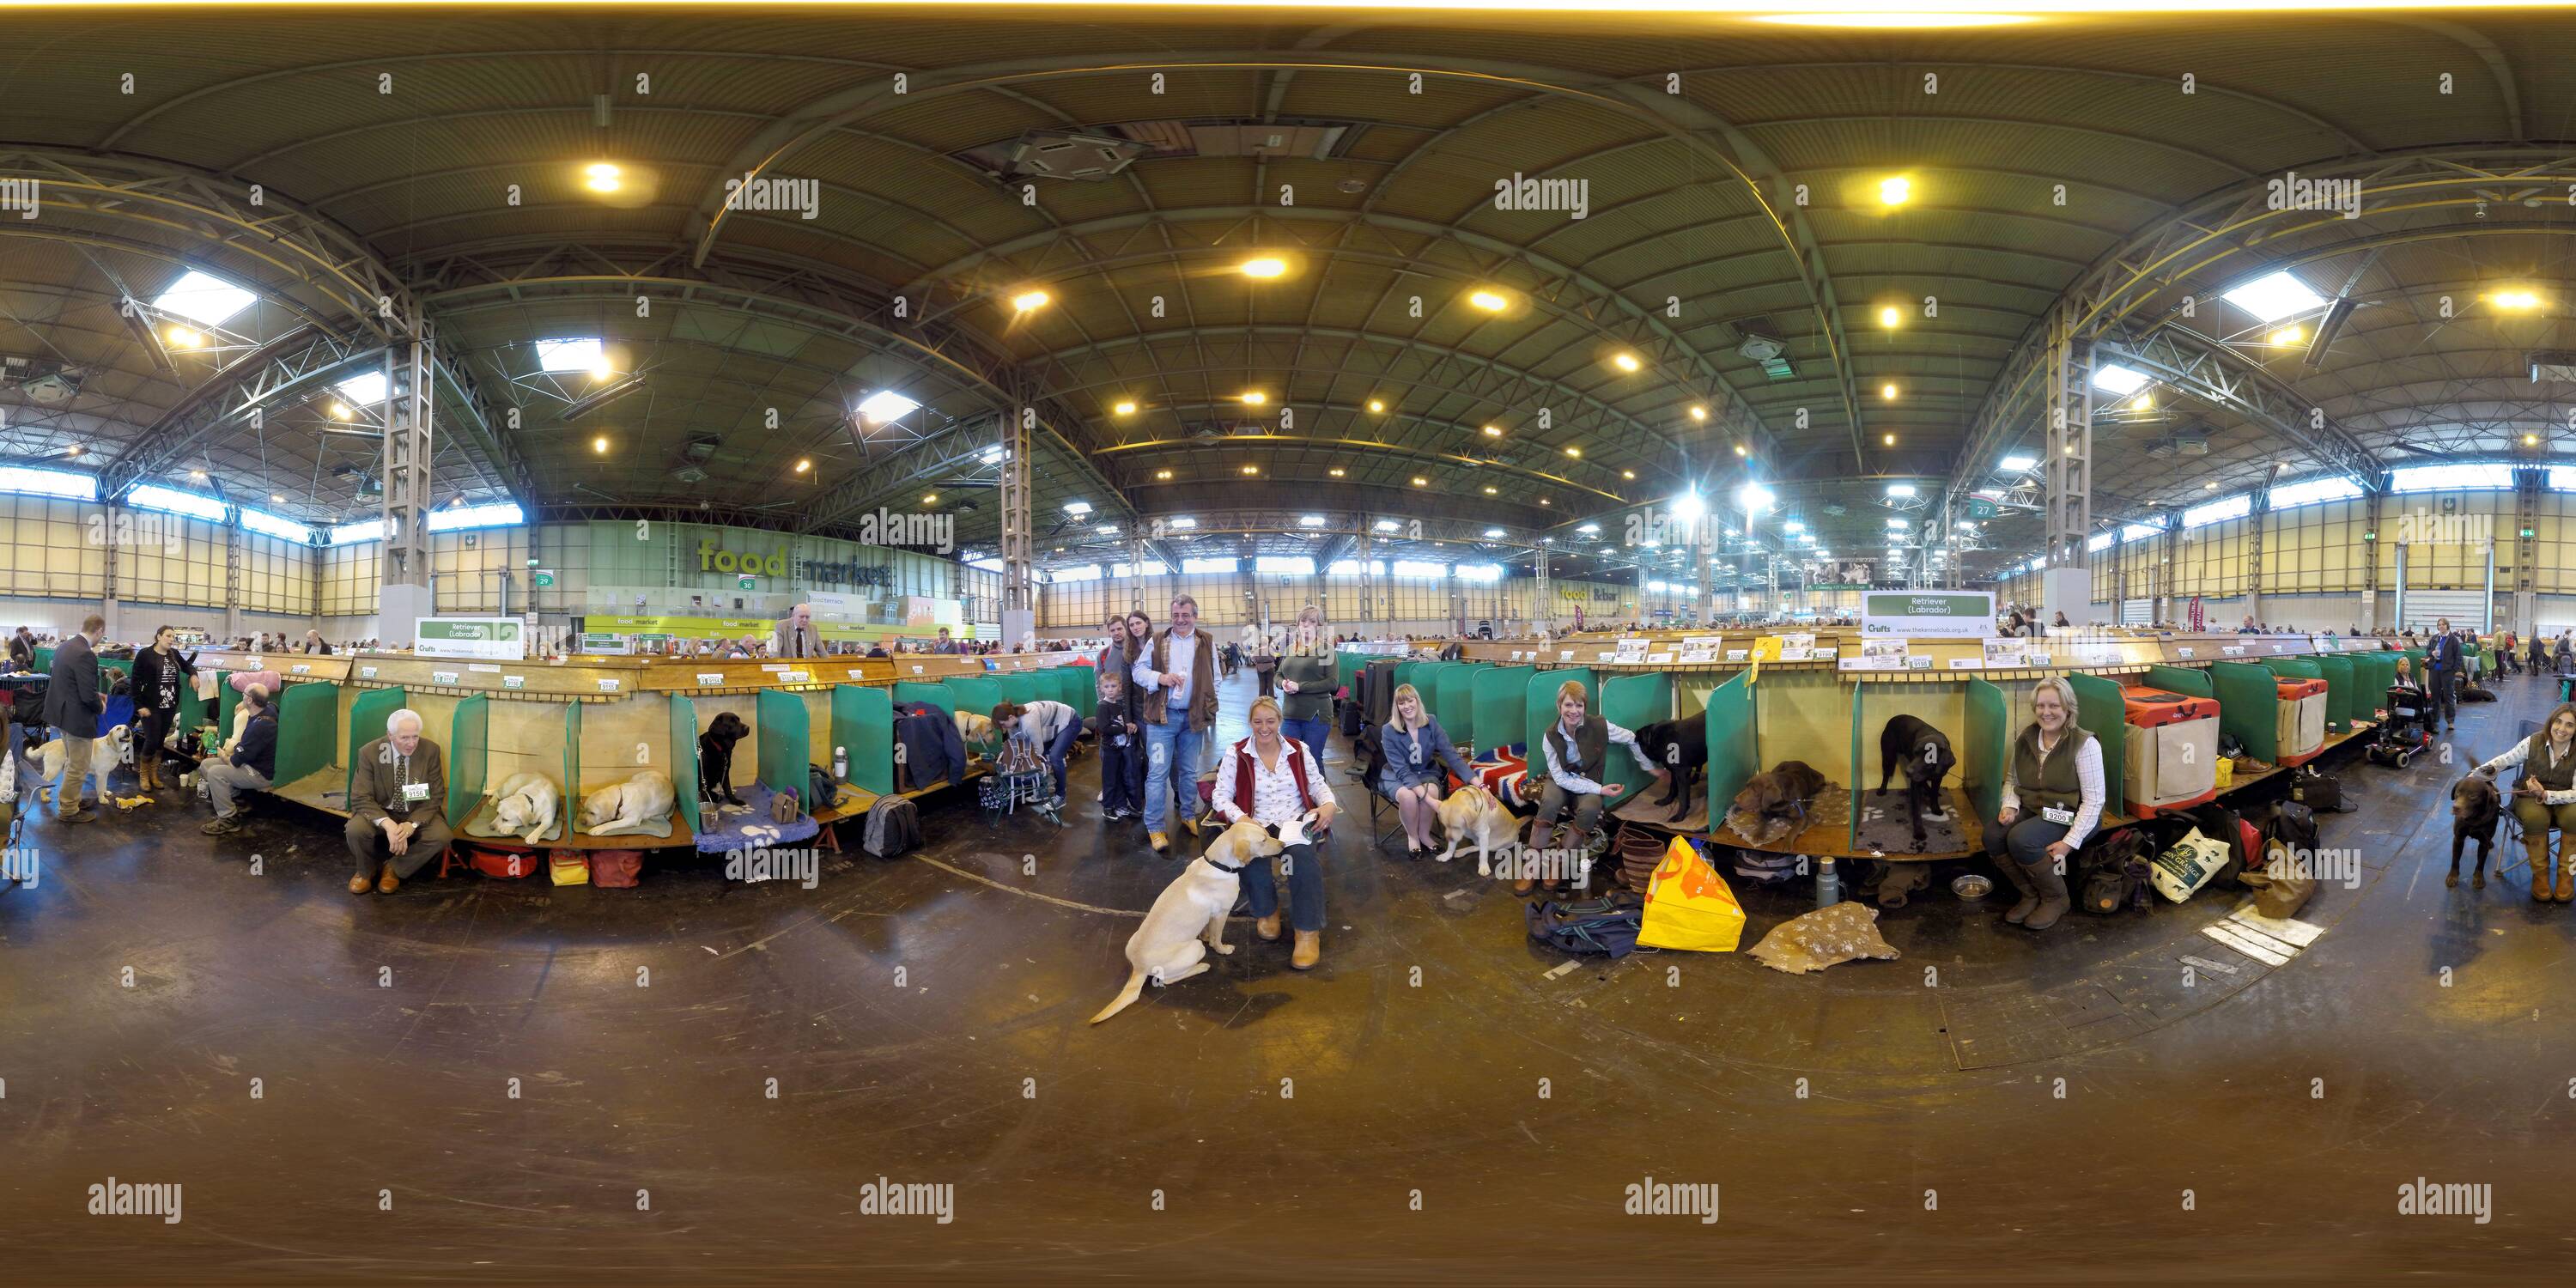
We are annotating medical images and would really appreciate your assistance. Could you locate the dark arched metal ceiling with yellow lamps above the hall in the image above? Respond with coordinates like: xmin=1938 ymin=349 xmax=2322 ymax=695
xmin=0 ymin=5 xmax=2576 ymax=585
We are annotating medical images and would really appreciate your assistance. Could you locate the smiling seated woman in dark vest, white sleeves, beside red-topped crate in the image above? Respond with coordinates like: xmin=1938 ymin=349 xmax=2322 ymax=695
xmin=1986 ymin=675 xmax=2110 ymax=930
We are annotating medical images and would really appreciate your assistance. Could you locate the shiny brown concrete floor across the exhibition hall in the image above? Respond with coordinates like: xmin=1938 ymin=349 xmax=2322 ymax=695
xmin=0 ymin=677 xmax=2576 ymax=1283
